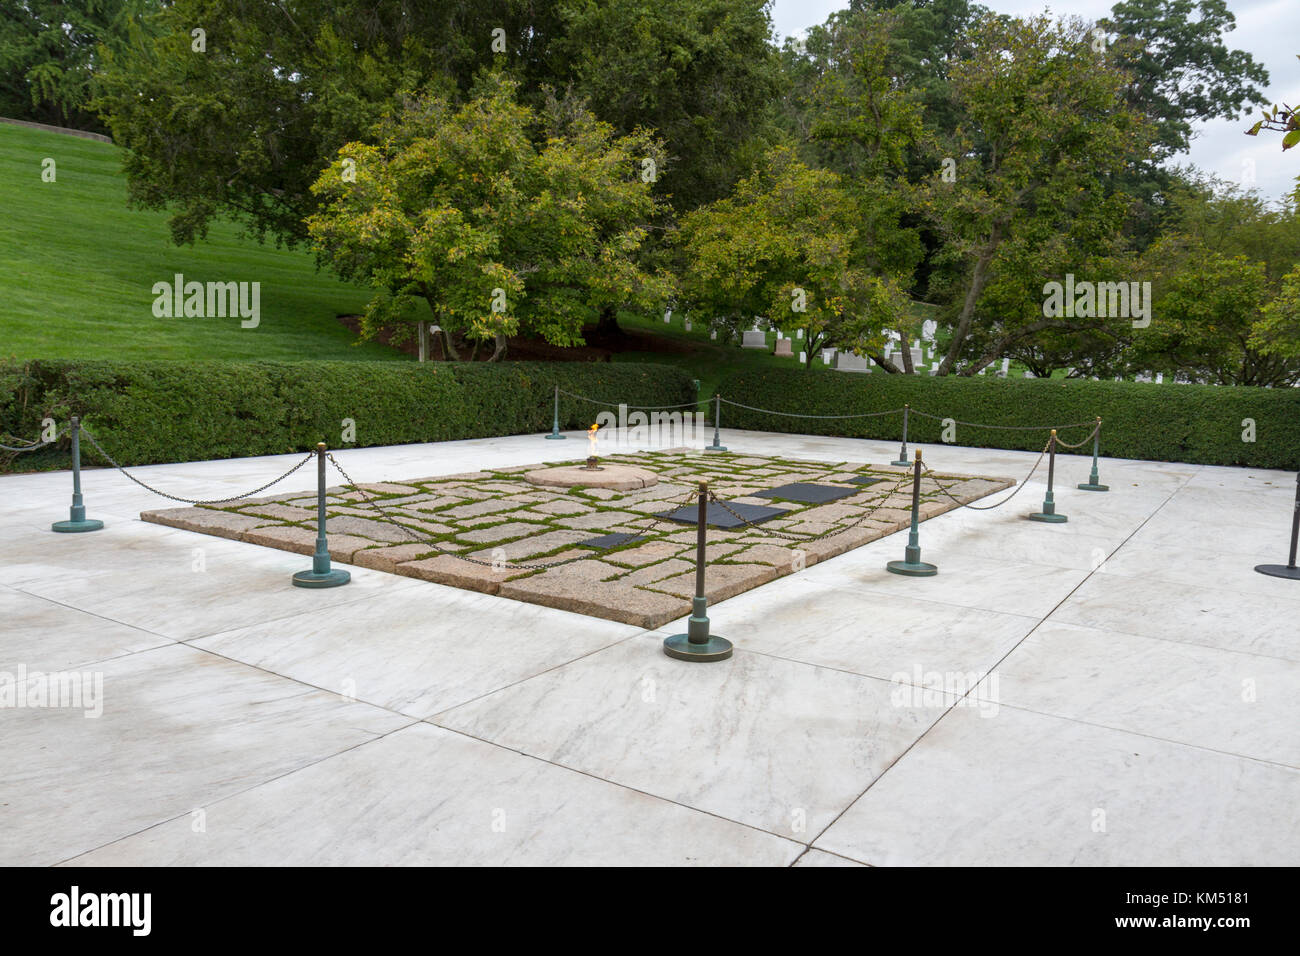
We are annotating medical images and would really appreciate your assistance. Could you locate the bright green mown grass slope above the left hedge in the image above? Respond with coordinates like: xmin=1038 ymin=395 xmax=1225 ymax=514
xmin=0 ymin=124 xmax=407 ymax=360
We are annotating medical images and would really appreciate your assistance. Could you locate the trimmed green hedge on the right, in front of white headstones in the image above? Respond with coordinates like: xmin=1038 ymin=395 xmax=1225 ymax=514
xmin=722 ymin=369 xmax=1300 ymax=470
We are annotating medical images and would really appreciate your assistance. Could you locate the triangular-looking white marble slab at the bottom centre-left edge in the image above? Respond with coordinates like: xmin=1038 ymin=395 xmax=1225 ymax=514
xmin=72 ymin=724 xmax=803 ymax=866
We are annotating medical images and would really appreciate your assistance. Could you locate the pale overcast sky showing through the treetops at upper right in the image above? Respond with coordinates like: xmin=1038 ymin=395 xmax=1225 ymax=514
xmin=772 ymin=0 xmax=1300 ymax=200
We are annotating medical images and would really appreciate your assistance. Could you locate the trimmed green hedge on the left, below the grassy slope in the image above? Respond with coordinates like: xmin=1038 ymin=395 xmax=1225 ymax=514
xmin=0 ymin=360 xmax=696 ymax=468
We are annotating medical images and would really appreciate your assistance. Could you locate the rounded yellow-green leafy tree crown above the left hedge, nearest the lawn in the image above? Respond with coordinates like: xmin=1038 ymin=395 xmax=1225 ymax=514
xmin=307 ymin=73 xmax=667 ymax=360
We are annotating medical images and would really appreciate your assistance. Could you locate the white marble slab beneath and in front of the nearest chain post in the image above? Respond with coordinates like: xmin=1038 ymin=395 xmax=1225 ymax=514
xmin=433 ymin=635 xmax=946 ymax=838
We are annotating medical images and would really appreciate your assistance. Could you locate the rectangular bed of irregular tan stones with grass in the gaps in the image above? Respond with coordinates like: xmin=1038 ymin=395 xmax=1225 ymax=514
xmin=142 ymin=450 xmax=1011 ymax=628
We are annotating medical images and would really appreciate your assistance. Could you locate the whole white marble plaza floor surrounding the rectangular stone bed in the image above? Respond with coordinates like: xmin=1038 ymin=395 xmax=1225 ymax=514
xmin=0 ymin=431 xmax=1300 ymax=866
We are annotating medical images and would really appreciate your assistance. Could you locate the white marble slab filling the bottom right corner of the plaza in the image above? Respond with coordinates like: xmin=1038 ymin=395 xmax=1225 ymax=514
xmin=814 ymin=708 xmax=1300 ymax=866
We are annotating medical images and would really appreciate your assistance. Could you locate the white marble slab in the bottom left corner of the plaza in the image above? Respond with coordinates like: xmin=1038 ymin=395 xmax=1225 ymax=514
xmin=0 ymin=644 xmax=411 ymax=866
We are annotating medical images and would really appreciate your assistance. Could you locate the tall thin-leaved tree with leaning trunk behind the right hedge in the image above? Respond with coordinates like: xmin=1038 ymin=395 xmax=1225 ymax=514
xmin=924 ymin=17 xmax=1149 ymax=375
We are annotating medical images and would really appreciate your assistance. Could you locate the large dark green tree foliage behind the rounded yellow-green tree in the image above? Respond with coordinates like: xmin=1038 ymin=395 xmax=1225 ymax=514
xmin=98 ymin=0 xmax=776 ymax=251
